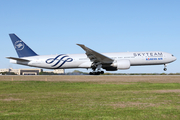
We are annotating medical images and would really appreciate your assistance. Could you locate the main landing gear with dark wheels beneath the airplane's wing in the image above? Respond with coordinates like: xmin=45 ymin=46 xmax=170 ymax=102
xmin=89 ymin=63 xmax=104 ymax=75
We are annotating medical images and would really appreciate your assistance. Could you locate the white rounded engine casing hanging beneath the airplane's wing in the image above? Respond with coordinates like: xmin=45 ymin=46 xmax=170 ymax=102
xmin=112 ymin=60 xmax=131 ymax=70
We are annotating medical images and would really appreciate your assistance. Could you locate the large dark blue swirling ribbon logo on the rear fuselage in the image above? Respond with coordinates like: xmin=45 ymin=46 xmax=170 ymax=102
xmin=46 ymin=54 xmax=73 ymax=69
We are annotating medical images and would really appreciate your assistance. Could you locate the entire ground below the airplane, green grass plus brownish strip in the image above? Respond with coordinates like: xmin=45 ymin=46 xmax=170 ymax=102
xmin=0 ymin=76 xmax=180 ymax=120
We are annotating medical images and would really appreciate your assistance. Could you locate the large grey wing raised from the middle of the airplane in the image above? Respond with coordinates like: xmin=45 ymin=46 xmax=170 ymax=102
xmin=77 ymin=44 xmax=114 ymax=64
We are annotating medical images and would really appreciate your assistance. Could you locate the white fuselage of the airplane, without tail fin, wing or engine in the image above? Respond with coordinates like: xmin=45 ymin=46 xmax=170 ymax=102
xmin=11 ymin=51 xmax=176 ymax=69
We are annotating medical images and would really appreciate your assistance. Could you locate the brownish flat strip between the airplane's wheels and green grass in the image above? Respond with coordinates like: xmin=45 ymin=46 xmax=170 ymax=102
xmin=0 ymin=75 xmax=180 ymax=83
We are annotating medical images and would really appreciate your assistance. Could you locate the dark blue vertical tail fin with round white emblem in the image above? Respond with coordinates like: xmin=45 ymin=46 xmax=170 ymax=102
xmin=9 ymin=34 xmax=37 ymax=58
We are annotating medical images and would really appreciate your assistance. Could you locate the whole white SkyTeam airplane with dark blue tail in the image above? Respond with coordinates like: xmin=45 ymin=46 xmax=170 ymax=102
xmin=7 ymin=34 xmax=176 ymax=75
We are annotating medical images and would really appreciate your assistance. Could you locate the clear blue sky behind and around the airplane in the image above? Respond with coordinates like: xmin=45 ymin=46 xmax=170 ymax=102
xmin=0 ymin=0 xmax=180 ymax=73
